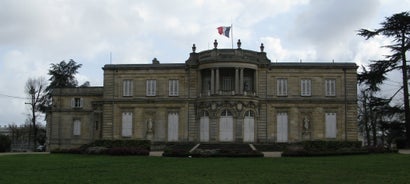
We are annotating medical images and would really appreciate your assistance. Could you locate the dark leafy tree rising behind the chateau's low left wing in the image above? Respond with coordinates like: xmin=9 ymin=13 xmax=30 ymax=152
xmin=40 ymin=59 xmax=81 ymax=112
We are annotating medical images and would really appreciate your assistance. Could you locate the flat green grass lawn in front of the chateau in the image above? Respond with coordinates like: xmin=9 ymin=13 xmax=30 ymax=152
xmin=0 ymin=154 xmax=410 ymax=184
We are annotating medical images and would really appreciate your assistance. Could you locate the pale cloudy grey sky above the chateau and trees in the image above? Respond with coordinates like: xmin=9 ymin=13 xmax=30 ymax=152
xmin=0 ymin=0 xmax=410 ymax=126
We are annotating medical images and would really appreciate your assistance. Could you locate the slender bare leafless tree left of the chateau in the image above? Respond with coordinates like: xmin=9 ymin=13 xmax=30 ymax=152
xmin=25 ymin=77 xmax=46 ymax=148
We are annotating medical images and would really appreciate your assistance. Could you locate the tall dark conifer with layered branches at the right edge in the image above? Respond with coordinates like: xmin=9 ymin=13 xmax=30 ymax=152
xmin=358 ymin=12 xmax=410 ymax=146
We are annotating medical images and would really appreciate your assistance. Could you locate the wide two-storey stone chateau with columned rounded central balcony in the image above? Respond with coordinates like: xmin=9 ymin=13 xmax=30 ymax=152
xmin=47 ymin=40 xmax=358 ymax=149
